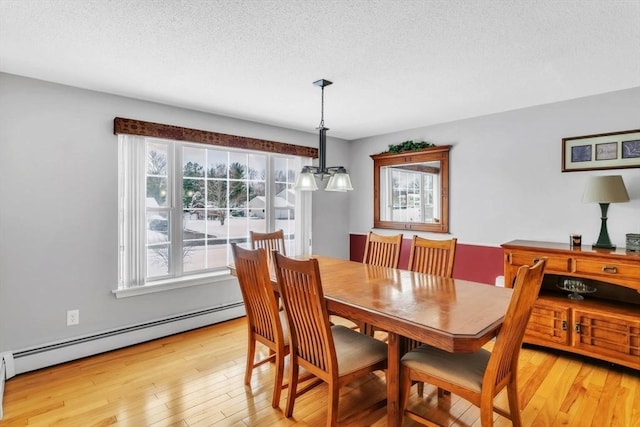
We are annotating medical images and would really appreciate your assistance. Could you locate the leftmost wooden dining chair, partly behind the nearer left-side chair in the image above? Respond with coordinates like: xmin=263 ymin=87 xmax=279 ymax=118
xmin=231 ymin=243 xmax=289 ymax=408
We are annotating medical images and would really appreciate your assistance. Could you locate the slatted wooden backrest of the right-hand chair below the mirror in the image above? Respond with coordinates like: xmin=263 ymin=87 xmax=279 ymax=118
xmin=409 ymin=236 xmax=458 ymax=277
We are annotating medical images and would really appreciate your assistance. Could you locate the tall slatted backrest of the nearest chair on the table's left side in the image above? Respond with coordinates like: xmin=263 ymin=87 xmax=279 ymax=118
xmin=274 ymin=253 xmax=338 ymax=378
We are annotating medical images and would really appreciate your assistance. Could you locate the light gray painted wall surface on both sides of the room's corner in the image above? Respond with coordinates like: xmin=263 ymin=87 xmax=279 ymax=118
xmin=0 ymin=73 xmax=640 ymax=360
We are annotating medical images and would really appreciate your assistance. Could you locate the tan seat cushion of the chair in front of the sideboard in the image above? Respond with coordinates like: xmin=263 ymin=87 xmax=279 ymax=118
xmin=401 ymin=345 xmax=491 ymax=393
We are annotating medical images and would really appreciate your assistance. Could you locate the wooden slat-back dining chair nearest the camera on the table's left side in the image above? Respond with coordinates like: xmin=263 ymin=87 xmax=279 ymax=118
xmin=274 ymin=253 xmax=387 ymax=426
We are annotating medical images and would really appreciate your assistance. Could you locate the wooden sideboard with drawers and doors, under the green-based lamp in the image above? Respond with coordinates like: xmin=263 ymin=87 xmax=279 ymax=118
xmin=502 ymin=240 xmax=640 ymax=369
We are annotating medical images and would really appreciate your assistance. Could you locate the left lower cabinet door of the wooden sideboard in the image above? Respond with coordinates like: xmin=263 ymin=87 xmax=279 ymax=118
xmin=525 ymin=299 xmax=569 ymax=345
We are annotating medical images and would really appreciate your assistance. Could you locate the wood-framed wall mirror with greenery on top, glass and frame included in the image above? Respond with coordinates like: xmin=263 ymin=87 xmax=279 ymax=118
xmin=371 ymin=145 xmax=451 ymax=233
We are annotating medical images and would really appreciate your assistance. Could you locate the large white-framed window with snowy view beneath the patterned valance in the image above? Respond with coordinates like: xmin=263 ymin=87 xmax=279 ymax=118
xmin=118 ymin=135 xmax=310 ymax=289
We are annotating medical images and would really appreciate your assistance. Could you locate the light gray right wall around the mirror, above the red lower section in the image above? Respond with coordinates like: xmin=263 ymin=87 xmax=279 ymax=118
xmin=349 ymin=87 xmax=640 ymax=247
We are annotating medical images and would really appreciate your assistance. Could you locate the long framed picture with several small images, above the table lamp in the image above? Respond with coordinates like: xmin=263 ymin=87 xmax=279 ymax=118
xmin=562 ymin=129 xmax=640 ymax=172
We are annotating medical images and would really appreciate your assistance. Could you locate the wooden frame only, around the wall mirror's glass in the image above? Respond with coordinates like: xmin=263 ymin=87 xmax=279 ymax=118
xmin=371 ymin=145 xmax=451 ymax=233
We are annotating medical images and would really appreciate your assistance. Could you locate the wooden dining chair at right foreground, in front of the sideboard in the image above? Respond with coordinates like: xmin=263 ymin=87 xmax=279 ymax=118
xmin=400 ymin=258 xmax=546 ymax=427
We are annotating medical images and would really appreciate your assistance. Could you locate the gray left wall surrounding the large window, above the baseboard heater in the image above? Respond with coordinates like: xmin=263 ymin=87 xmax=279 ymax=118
xmin=0 ymin=73 xmax=348 ymax=352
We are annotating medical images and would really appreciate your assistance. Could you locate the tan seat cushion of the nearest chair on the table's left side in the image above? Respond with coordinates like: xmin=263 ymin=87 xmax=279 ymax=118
xmin=331 ymin=325 xmax=387 ymax=376
